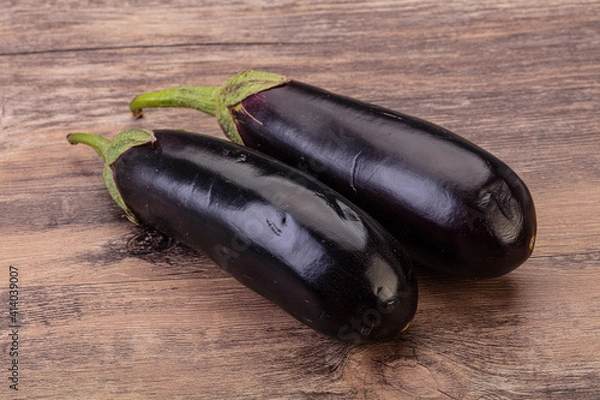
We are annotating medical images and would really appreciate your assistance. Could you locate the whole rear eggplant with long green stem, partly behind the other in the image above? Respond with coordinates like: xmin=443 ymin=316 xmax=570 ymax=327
xmin=130 ymin=71 xmax=537 ymax=278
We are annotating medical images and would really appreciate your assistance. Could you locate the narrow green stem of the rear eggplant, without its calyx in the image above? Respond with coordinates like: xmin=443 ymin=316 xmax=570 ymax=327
xmin=129 ymin=86 xmax=220 ymax=118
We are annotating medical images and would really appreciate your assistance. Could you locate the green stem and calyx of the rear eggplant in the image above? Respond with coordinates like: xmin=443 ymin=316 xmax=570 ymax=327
xmin=129 ymin=71 xmax=290 ymax=144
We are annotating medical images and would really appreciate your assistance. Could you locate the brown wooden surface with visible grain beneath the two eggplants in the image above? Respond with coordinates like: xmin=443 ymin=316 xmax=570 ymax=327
xmin=0 ymin=0 xmax=600 ymax=399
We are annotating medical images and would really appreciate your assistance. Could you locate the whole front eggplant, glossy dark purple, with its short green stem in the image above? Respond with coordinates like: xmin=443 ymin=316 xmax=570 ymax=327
xmin=68 ymin=130 xmax=418 ymax=343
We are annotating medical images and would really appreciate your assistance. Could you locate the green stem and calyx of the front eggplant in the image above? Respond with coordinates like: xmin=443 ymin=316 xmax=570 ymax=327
xmin=67 ymin=129 xmax=156 ymax=224
